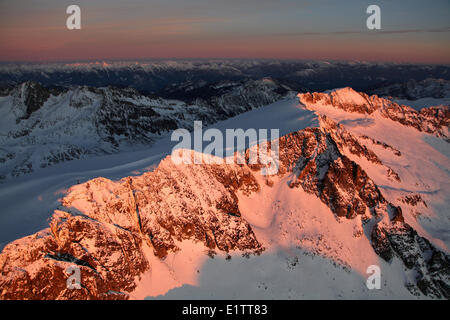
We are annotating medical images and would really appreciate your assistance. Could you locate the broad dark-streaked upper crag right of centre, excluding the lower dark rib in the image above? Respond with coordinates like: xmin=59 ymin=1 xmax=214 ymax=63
xmin=270 ymin=117 xmax=394 ymax=218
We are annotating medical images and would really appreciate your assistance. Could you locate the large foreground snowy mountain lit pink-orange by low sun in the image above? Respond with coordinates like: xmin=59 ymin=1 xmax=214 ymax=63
xmin=0 ymin=82 xmax=450 ymax=299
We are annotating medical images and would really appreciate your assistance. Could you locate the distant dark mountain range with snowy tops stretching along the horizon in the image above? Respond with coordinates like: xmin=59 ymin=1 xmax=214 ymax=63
xmin=0 ymin=59 xmax=450 ymax=95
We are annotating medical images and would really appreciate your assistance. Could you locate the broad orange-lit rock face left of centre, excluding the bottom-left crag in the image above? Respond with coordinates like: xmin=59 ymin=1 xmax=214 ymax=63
xmin=62 ymin=158 xmax=262 ymax=258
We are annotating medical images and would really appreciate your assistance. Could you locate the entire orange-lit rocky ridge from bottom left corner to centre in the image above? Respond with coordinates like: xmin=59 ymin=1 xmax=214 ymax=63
xmin=0 ymin=154 xmax=263 ymax=299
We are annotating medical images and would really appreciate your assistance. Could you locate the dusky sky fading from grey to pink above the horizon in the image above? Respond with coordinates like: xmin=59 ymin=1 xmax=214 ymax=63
xmin=0 ymin=0 xmax=450 ymax=64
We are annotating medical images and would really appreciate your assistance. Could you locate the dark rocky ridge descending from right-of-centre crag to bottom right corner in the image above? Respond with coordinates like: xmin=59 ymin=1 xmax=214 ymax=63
xmin=272 ymin=120 xmax=450 ymax=299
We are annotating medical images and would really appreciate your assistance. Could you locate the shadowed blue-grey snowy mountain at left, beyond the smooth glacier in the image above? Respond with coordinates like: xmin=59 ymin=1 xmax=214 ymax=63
xmin=0 ymin=79 xmax=292 ymax=181
